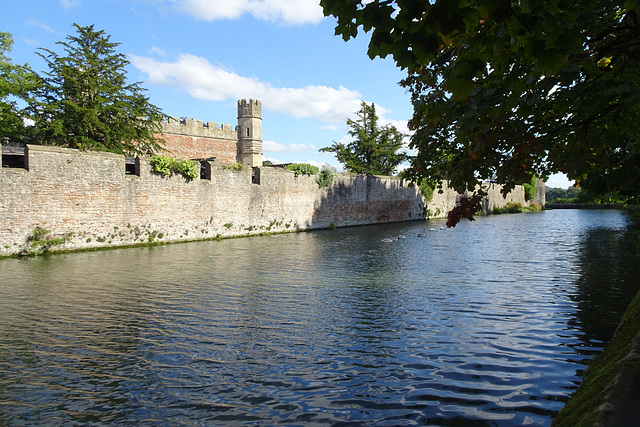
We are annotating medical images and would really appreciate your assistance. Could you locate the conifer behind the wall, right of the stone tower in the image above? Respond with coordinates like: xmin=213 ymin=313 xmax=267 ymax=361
xmin=320 ymin=101 xmax=407 ymax=176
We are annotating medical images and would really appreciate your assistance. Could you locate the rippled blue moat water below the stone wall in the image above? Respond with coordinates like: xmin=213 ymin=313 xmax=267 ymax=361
xmin=0 ymin=210 xmax=640 ymax=426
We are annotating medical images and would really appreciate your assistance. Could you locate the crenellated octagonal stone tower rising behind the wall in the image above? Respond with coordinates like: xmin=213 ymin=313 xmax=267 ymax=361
xmin=238 ymin=99 xmax=262 ymax=167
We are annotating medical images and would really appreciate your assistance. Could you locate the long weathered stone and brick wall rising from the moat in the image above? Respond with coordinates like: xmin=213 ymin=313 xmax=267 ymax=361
xmin=0 ymin=145 xmax=544 ymax=256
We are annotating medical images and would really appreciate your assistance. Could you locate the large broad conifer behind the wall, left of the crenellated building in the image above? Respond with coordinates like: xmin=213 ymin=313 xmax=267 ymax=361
xmin=30 ymin=24 xmax=164 ymax=155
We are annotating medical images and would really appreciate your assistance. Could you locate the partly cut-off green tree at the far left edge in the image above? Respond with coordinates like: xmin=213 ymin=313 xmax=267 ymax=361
xmin=0 ymin=32 xmax=40 ymax=144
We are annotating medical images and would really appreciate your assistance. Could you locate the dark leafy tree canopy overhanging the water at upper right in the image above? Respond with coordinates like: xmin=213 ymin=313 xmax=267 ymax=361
xmin=321 ymin=0 xmax=640 ymax=224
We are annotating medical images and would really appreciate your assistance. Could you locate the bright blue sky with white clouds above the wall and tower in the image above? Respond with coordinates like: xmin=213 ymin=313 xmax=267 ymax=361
xmin=0 ymin=0 xmax=570 ymax=188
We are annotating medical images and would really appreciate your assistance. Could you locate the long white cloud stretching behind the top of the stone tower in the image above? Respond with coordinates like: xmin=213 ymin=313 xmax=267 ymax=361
xmin=130 ymin=54 xmax=361 ymax=123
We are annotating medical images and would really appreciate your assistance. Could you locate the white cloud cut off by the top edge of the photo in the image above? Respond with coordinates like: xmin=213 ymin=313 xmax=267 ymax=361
xmin=170 ymin=0 xmax=324 ymax=25
